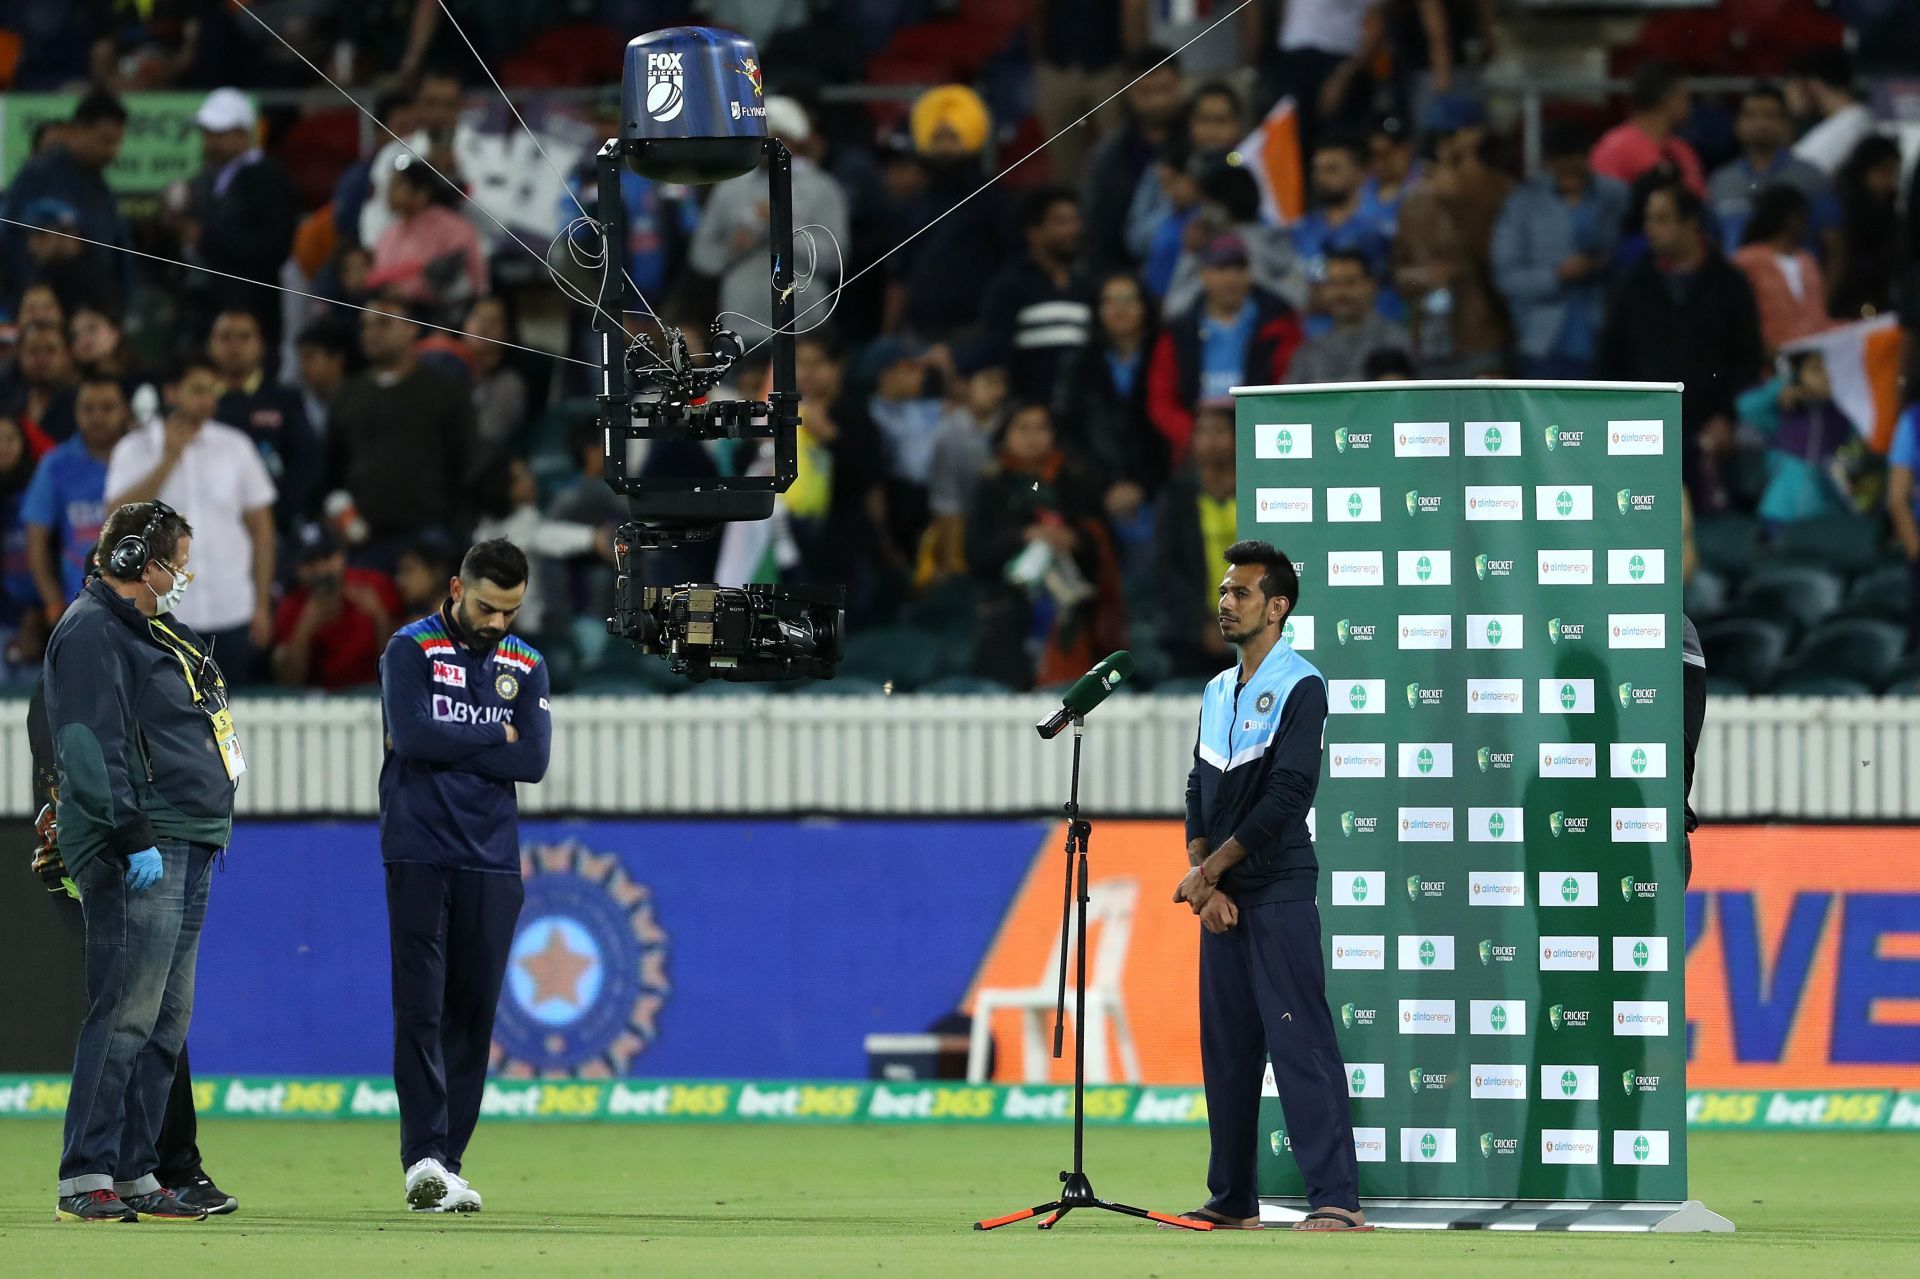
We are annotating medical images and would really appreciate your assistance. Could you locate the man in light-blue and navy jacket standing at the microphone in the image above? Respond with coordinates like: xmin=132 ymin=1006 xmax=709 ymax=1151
xmin=1173 ymin=542 xmax=1373 ymax=1231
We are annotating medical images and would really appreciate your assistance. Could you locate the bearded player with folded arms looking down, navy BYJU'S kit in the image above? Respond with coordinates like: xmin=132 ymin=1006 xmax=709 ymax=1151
xmin=380 ymin=540 xmax=553 ymax=1212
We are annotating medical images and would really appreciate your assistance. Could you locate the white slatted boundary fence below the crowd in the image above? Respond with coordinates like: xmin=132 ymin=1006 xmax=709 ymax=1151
xmin=0 ymin=695 xmax=1920 ymax=822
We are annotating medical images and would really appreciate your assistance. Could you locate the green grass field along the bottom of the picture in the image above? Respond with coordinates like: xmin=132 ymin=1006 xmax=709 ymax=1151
xmin=0 ymin=1120 xmax=1920 ymax=1279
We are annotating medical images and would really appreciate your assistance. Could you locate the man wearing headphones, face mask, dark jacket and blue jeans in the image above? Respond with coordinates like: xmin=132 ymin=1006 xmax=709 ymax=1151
xmin=46 ymin=501 xmax=246 ymax=1221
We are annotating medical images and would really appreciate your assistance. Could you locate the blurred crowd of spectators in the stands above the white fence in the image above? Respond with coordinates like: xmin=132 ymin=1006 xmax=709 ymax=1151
xmin=0 ymin=0 xmax=1920 ymax=691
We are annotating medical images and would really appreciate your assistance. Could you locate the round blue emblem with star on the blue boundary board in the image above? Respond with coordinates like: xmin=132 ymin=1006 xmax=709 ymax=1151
xmin=492 ymin=841 xmax=672 ymax=1079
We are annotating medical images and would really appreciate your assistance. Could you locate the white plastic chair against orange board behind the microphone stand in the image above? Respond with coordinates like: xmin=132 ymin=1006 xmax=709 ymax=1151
xmin=966 ymin=880 xmax=1140 ymax=1083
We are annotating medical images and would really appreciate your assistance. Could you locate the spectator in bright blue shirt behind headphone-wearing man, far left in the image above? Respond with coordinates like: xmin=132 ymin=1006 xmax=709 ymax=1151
xmin=19 ymin=374 xmax=127 ymax=626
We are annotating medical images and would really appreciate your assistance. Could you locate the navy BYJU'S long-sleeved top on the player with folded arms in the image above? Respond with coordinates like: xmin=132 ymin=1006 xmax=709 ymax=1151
xmin=380 ymin=605 xmax=553 ymax=876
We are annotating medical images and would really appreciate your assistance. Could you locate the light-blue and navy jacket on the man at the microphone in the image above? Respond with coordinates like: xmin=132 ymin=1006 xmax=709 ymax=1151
xmin=1187 ymin=640 xmax=1327 ymax=910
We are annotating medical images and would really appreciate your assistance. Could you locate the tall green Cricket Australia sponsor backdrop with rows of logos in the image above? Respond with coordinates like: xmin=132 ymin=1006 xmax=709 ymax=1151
xmin=1236 ymin=382 xmax=1686 ymax=1200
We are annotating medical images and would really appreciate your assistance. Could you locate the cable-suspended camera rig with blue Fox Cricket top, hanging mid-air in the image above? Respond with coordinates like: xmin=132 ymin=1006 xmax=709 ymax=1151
xmin=593 ymin=27 xmax=845 ymax=682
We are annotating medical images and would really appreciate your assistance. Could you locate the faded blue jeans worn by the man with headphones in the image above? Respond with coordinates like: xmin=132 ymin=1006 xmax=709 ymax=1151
xmin=60 ymin=839 xmax=215 ymax=1195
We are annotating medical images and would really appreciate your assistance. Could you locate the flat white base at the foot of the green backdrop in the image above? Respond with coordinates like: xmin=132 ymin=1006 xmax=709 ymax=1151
xmin=1260 ymin=1198 xmax=1734 ymax=1235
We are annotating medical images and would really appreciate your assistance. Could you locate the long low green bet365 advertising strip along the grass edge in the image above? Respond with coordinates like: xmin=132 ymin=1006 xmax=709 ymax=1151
xmin=0 ymin=1075 xmax=1920 ymax=1139
